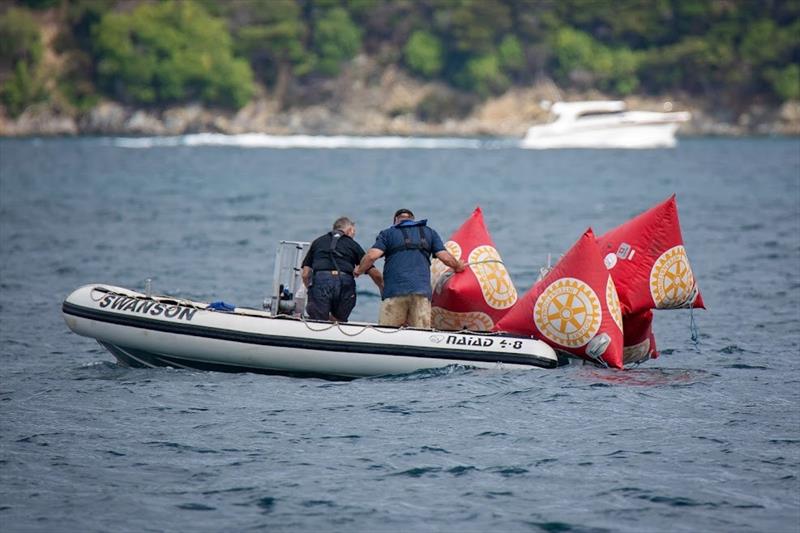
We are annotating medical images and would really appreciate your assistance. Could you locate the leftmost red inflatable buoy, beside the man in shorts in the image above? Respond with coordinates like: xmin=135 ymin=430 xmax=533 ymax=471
xmin=431 ymin=207 xmax=517 ymax=331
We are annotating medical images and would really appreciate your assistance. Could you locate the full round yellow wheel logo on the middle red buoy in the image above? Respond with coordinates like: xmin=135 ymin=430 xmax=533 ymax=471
xmin=533 ymin=278 xmax=603 ymax=348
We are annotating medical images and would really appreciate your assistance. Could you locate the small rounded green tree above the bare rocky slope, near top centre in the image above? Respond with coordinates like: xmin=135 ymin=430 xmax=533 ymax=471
xmin=314 ymin=7 xmax=361 ymax=76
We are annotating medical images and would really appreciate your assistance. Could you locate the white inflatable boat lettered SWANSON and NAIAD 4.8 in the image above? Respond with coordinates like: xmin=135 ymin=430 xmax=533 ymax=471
xmin=62 ymin=284 xmax=559 ymax=379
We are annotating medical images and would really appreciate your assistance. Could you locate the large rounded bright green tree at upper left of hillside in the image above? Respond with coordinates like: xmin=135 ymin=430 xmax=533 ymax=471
xmin=93 ymin=0 xmax=253 ymax=107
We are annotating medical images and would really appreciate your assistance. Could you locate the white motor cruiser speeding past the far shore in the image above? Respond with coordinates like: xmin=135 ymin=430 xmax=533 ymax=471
xmin=521 ymin=100 xmax=691 ymax=149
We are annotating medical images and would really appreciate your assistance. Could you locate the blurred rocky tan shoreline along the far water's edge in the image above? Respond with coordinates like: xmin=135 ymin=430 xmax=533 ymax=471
xmin=0 ymin=61 xmax=800 ymax=137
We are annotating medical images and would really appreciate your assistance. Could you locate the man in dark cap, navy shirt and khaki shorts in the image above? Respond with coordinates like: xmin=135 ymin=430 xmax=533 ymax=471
xmin=353 ymin=209 xmax=465 ymax=329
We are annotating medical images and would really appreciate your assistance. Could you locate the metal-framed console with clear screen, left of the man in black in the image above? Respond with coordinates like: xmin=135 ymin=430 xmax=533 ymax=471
xmin=264 ymin=241 xmax=311 ymax=316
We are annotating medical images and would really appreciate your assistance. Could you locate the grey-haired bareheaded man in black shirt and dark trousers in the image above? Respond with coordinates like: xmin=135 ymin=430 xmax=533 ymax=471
xmin=303 ymin=217 xmax=383 ymax=322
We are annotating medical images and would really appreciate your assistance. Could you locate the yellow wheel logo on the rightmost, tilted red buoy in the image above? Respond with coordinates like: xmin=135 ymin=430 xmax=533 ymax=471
xmin=650 ymin=246 xmax=694 ymax=309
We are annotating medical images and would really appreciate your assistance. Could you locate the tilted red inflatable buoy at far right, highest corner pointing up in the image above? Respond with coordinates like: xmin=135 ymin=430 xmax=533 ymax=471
xmin=597 ymin=194 xmax=705 ymax=314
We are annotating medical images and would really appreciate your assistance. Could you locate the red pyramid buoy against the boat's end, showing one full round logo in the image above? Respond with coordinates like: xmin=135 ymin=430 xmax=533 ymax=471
xmin=494 ymin=228 xmax=623 ymax=368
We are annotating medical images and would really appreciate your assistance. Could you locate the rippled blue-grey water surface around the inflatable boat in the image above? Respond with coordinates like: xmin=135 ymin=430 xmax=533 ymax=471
xmin=0 ymin=139 xmax=800 ymax=532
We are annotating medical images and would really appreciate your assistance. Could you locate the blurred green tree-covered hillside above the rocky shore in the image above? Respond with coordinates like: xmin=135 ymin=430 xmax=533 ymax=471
xmin=0 ymin=0 xmax=800 ymax=116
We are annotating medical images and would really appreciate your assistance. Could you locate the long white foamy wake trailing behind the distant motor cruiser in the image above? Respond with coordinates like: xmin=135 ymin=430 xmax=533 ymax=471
xmin=112 ymin=133 xmax=496 ymax=150
